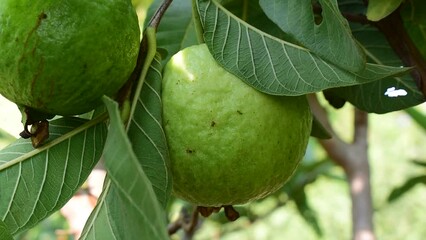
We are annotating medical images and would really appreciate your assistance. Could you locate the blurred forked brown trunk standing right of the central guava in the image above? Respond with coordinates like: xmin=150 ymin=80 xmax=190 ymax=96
xmin=308 ymin=95 xmax=375 ymax=240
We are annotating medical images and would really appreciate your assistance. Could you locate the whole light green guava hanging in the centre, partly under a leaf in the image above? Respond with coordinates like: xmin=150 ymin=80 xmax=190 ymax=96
xmin=162 ymin=44 xmax=312 ymax=207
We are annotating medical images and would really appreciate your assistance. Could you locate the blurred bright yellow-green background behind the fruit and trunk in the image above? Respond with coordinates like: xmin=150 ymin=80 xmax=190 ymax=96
xmin=0 ymin=94 xmax=426 ymax=240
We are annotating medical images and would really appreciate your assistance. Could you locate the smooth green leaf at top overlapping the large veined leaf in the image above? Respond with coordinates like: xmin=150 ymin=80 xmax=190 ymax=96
xmin=260 ymin=0 xmax=366 ymax=72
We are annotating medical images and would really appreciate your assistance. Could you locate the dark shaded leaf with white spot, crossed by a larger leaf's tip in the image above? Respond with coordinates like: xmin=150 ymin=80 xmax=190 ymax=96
xmin=327 ymin=20 xmax=425 ymax=113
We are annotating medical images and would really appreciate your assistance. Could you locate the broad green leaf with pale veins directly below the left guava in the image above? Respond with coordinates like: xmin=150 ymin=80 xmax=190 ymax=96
xmin=0 ymin=117 xmax=106 ymax=234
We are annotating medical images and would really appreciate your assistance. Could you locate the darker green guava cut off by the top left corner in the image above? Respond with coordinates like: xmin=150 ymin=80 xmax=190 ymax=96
xmin=0 ymin=0 xmax=140 ymax=115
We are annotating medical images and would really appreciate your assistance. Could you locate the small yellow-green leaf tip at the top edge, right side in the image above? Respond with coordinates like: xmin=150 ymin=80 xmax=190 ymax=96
xmin=367 ymin=0 xmax=403 ymax=21
